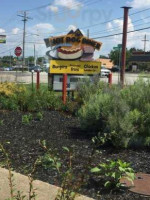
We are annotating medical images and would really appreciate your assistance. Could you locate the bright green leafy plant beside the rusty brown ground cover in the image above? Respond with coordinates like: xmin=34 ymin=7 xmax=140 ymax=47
xmin=91 ymin=160 xmax=135 ymax=189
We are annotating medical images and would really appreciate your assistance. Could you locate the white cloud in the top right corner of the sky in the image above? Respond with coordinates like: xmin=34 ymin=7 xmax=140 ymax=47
xmin=127 ymin=0 xmax=150 ymax=9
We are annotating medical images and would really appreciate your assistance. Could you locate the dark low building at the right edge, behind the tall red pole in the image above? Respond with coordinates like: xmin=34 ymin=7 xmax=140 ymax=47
xmin=129 ymin=52 xmax=150 ymax=71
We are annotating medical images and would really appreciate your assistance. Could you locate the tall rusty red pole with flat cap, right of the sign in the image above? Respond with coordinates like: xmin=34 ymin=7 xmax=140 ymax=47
xmin=120 ymin=7 xmax=131 ymax=87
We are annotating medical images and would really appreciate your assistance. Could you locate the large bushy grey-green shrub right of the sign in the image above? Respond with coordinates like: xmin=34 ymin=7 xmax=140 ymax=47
xmin=78 ymin=80 xmax=150 ymax=147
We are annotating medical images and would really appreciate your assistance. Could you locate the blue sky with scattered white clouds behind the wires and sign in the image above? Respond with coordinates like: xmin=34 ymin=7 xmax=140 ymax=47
xmin=0 ymin=0 xmax=150 ymax=58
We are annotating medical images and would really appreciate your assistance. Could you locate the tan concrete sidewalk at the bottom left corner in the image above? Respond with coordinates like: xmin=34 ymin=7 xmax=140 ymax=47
xmin=0 ymin=168 xmax=93 ymax=200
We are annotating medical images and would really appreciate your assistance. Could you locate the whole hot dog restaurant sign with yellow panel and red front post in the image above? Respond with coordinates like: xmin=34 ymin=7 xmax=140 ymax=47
xmin=44 ymin=29 xmax=102 ymax=104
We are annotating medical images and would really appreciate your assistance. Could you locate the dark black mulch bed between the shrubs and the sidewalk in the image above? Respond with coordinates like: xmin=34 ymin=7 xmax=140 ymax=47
xmin=0 ymin=111 xmax=150 ymax=200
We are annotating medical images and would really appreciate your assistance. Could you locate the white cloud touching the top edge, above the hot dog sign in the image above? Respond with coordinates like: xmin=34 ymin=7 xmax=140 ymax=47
xmin=54 ymin=0 xmax=83 ymax=10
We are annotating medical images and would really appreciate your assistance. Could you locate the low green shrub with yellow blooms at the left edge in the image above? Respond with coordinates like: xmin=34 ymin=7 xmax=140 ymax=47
xmin=0 ymin=83 xmax=62 ymax=112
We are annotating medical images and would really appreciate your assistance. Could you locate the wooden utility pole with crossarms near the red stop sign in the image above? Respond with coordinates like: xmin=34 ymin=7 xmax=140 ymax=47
xmin=18 ymin=11 xmax=32 ymax=72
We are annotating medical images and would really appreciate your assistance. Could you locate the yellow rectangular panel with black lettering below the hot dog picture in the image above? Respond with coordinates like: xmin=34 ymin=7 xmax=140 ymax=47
xmin=50 ymin=60 xmax=101 ymax=75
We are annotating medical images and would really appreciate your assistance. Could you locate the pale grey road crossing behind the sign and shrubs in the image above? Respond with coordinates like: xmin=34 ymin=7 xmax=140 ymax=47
xmin=0 ymin=71 xmax=150 ymax=85
